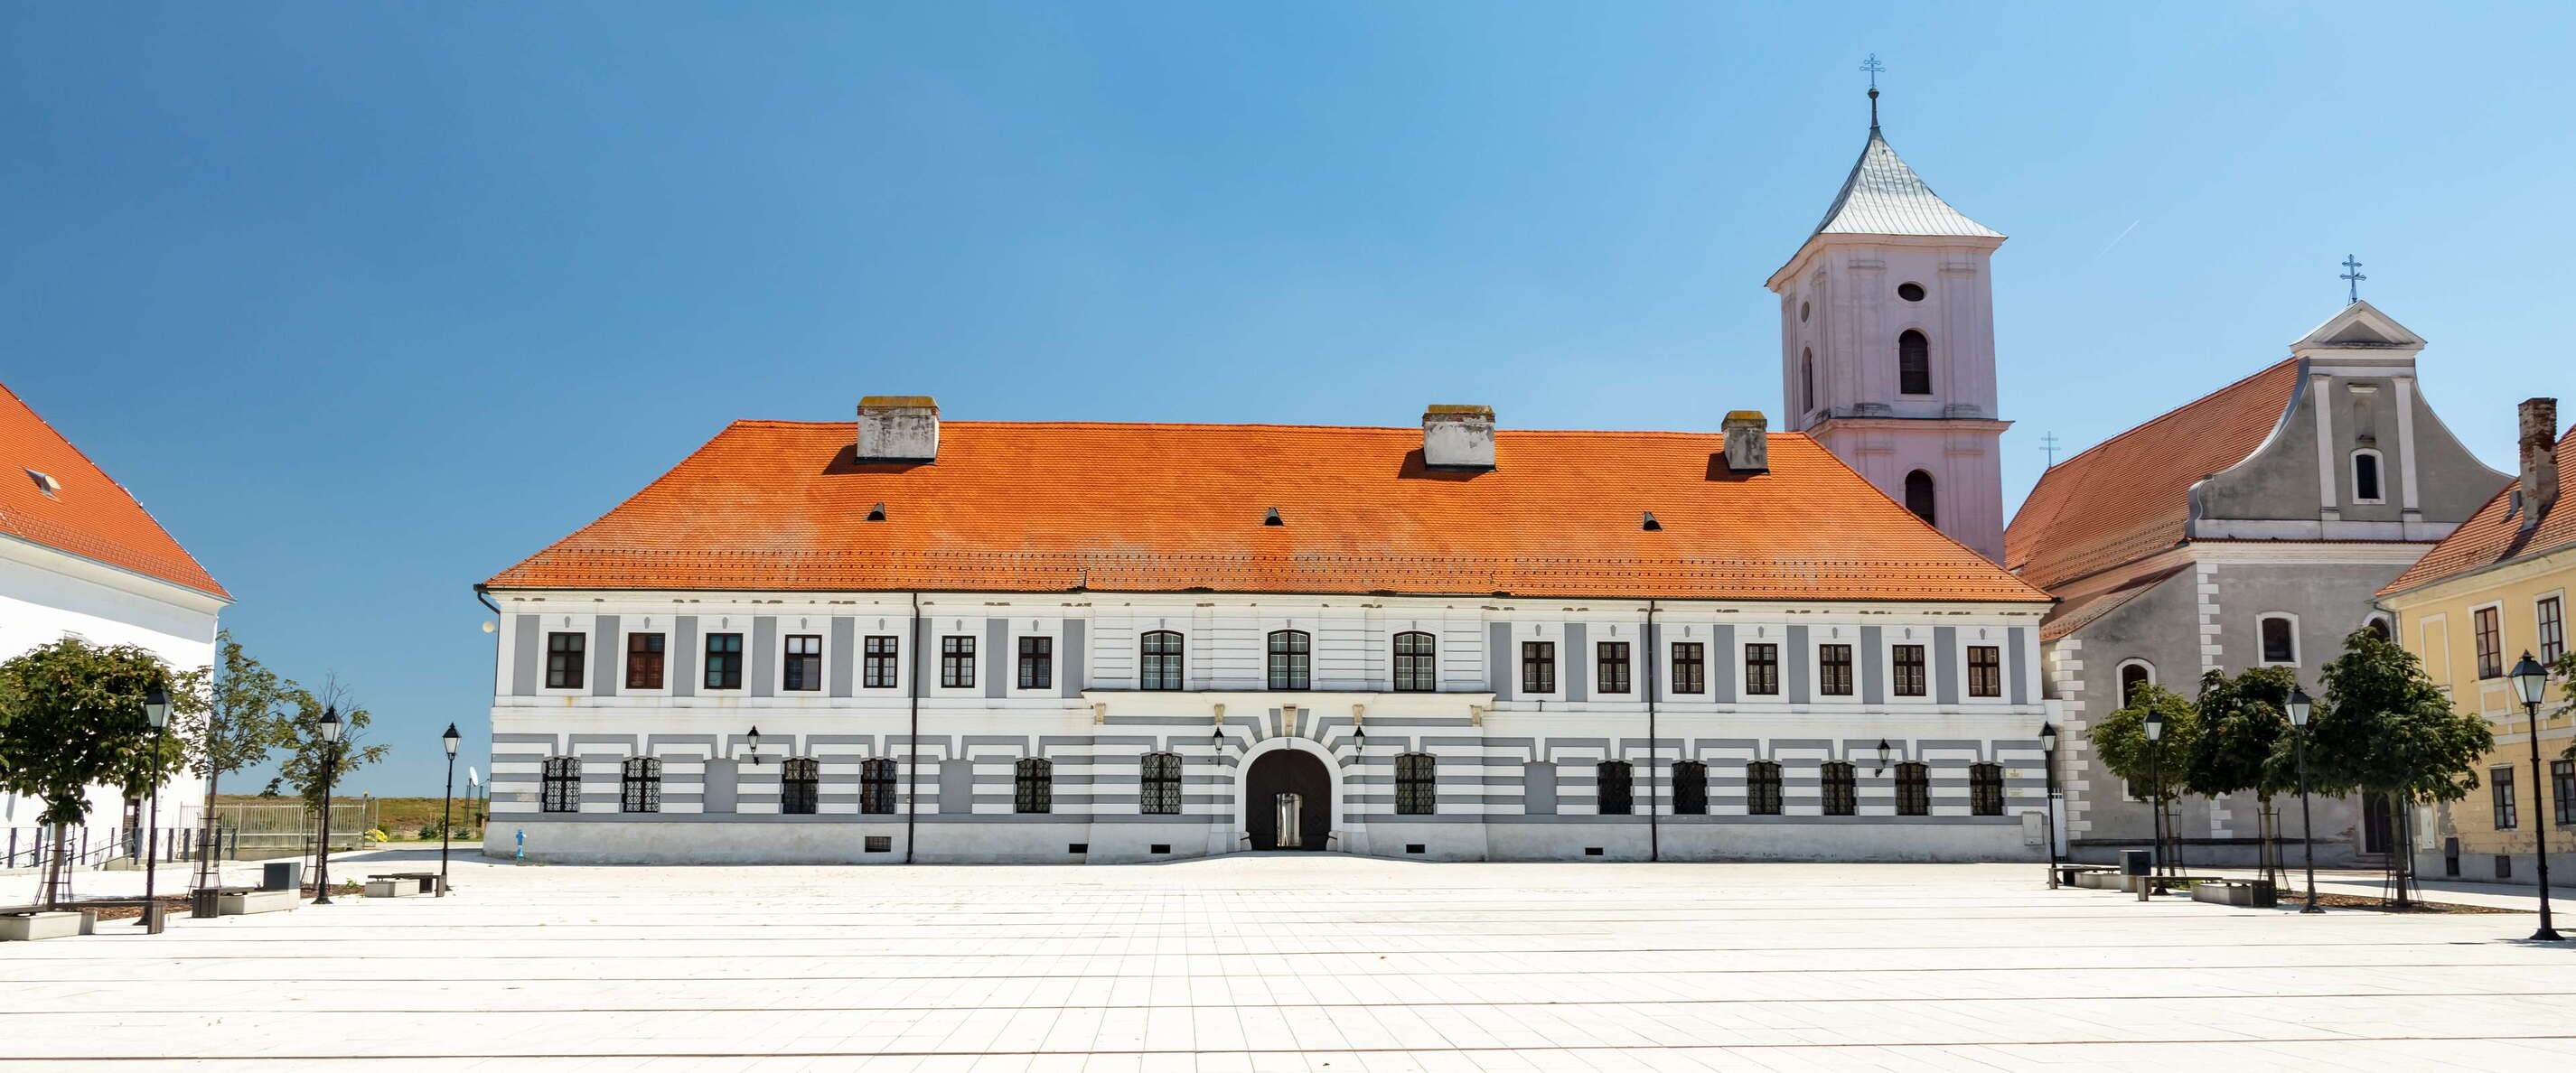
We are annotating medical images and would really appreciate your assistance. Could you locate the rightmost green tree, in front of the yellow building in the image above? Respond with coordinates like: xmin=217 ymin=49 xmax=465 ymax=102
xmin=2308 ymin=630 xmax=2496 ymax=906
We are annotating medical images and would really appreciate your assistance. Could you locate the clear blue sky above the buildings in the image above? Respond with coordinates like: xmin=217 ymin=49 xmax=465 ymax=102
xmin=0 ymin=3 xmax=2576 ymax=792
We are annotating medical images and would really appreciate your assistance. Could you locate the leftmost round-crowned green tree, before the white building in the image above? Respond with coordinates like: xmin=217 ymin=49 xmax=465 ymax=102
xmin=0 ymin=639 xmax=188 ymax=909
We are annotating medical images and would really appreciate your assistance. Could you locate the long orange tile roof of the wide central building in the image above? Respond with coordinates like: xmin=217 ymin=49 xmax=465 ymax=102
xmin=487 ymin=422 xmax=2048 ymax=602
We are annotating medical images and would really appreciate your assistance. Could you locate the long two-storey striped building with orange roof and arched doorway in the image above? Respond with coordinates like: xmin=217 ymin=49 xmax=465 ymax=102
xmin=479 ymin=397 xmax=2048 ymax=862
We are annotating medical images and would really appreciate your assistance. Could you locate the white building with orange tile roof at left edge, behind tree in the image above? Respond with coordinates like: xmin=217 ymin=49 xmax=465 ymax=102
xmin=0 ymin=386 xmax=232 ymax=867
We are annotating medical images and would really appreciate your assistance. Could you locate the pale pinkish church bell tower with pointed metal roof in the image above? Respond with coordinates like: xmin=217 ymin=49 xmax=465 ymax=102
xmin=1770 ymin=85 xmax=2012 ymax=561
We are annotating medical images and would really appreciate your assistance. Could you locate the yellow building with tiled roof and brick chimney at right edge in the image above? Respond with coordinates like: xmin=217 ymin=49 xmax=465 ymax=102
xmin=2380 ymin=399 xmax=2576 ymax=888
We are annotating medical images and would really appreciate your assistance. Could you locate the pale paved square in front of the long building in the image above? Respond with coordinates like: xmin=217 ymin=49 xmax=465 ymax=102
xmin=0 ymin=854 xmax=2576 ymax=1073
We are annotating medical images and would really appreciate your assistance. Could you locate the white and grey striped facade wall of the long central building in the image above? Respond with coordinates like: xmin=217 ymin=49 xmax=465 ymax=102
xmin=487 ymin=589 xmax=2048 ymax=862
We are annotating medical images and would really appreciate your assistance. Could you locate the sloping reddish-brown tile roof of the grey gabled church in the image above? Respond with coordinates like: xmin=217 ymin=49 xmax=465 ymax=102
xmin=2004 ymin=358 xmax=2298 ymax=589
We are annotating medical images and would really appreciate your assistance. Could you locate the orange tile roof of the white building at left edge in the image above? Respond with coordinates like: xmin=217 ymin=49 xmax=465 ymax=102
xmin=0 ymin=383 xmax=232 ymax=600
